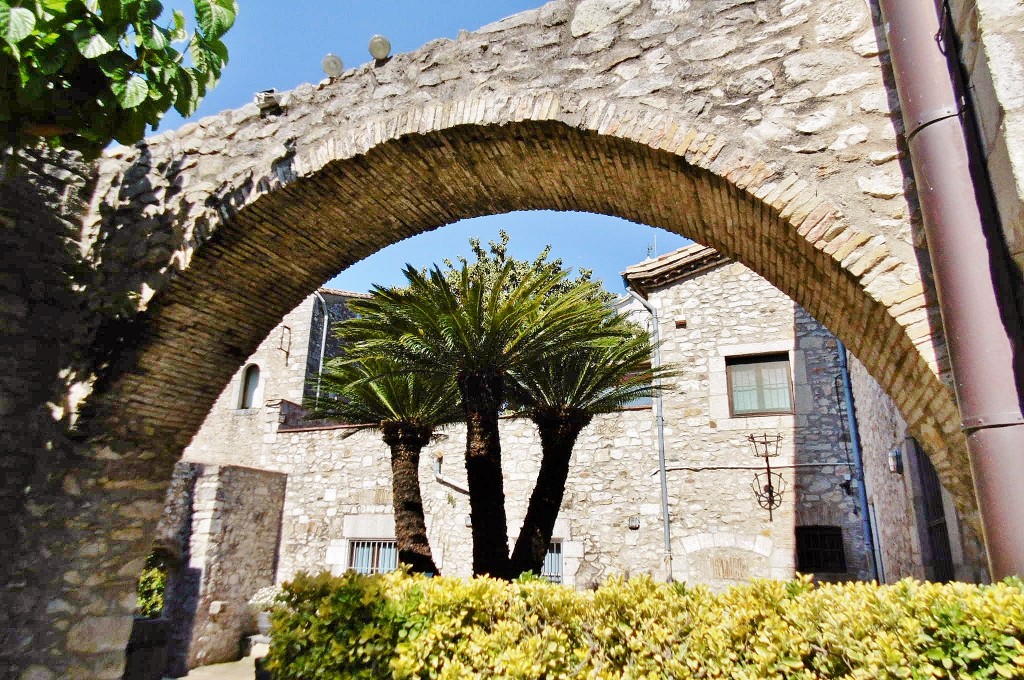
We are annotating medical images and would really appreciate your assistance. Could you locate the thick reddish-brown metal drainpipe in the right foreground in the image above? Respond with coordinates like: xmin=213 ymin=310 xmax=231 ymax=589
xmin=879 ymin=0 xmax=1024 ymax=580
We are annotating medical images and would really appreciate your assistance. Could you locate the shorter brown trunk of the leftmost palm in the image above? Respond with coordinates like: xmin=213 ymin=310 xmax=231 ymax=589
xmin=383 ymin=423 xmax=438 ymax=573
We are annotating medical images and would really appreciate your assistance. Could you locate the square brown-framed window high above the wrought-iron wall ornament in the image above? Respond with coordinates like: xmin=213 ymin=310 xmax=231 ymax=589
xmin=725 ymin=353 xmax=793 ymax=416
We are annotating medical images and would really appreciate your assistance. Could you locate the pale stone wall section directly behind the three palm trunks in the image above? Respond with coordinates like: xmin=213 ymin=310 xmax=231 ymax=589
xmin=268 ymin=410 xmax=647 ymax=585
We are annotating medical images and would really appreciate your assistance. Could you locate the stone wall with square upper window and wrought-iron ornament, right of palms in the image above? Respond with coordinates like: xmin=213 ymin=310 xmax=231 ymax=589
xmin=650 ymin=263 xmax=867 ymax=579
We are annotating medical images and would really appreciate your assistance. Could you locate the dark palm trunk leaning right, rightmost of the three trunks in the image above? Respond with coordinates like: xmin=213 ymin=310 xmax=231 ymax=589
xmin=511 ymin=413 xmax=591 ymax=577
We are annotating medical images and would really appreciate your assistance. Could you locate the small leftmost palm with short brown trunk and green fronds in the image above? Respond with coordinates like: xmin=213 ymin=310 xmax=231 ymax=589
xmin=307 ymin=351 xmax=461 ymax=573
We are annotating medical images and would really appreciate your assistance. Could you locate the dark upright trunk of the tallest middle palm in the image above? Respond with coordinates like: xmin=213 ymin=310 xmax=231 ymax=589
xmin=459 ymin=373 xmax=511 ymax=579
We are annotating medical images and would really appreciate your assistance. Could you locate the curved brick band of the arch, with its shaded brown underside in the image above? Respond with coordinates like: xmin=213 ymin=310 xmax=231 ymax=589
xmin=86 ymin=98 xmax=973 ymax=508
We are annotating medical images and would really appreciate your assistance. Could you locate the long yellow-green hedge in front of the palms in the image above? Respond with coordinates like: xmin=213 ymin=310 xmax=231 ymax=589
xmin=266 ymin=572 xmax=1024 ymax=680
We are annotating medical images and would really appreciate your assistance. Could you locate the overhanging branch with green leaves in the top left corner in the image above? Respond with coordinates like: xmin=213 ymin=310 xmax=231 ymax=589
xmin=0 ymin=0 xmax=239 ymax=158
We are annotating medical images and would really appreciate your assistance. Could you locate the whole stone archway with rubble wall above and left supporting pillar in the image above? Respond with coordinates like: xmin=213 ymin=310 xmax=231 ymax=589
xmin=11 ymin=0 xmax=987 ymax=677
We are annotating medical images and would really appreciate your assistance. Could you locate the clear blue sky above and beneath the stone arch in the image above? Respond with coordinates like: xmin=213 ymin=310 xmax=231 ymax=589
xmin=161 ymin=0 xmax=688 ymax=293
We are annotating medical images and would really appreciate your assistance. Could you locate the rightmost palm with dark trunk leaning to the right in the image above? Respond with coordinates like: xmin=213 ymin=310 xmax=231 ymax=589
xmin=510 ymin=319 xmax=670 ymax=575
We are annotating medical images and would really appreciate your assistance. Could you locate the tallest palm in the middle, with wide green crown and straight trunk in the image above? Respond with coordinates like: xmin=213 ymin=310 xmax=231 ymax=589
xmin=339 ymin=262 xmax=606 ymax=579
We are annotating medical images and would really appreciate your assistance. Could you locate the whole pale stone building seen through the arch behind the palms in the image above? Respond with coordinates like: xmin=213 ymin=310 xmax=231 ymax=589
xmin=160 ymin=245 xmax=981 ymax=670
